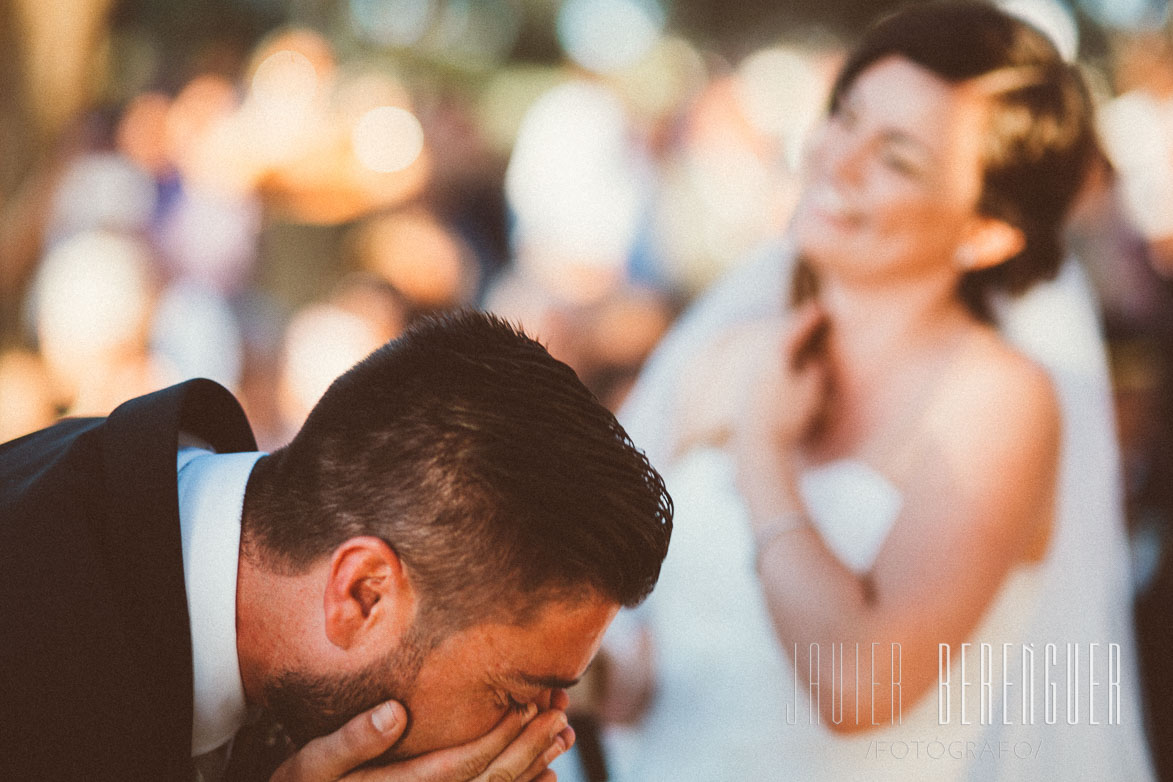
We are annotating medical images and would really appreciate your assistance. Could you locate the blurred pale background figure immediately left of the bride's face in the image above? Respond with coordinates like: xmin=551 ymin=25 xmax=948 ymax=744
xmin=647 ymin=42 xmax=841 ymax=295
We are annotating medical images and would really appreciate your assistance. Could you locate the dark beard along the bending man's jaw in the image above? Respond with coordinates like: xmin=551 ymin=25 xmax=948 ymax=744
xmin=263 ymin=627 xmax=434 ymax=760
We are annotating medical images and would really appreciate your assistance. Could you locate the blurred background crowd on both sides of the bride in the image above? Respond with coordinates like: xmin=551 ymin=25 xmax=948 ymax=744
xmin=0 ymin=0 xmax=1173 ymax=604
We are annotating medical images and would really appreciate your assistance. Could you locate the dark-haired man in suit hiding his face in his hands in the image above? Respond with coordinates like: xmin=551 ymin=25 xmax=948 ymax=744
xmin=0 ymin=313 xmax=672 ymax=781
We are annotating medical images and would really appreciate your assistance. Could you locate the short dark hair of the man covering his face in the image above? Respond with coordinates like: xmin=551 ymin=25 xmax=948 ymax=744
xmin=244 ymin=311 xmax=672 ymax=628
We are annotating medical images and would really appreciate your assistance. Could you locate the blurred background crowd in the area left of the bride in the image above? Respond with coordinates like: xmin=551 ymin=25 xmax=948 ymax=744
xmin=0 ymin=2 xmax=839 ymax=448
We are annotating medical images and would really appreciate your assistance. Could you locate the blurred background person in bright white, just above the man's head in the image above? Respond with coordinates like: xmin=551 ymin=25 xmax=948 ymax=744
xmin=484 ymin=69 xmax=678 ymax=419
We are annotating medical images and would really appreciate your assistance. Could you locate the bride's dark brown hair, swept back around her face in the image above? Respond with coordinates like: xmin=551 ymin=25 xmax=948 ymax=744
xmin=830 ymin=1 xmax=1098 ymax=318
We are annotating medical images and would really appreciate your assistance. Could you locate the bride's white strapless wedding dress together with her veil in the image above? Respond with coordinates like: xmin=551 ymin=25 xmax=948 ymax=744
xmin=610 ymin=241 xmax=1153 ymax=782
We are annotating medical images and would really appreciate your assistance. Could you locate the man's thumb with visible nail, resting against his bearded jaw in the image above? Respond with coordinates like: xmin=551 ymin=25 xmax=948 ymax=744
xmin=270 ymin=701 xmax=407 ymax=782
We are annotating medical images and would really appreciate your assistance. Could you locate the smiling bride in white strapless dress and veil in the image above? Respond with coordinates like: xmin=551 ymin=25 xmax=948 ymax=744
xmin=619 ymin=2 xmax=1152 ymax=782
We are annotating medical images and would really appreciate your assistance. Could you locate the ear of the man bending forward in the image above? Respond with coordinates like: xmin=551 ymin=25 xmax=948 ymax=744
xmin=323 ymin=536 xmax=415 ymax=650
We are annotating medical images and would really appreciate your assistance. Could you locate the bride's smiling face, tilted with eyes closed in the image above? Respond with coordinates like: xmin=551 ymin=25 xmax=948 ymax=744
xmin=792 ymin=56 xmax=988 ymax=284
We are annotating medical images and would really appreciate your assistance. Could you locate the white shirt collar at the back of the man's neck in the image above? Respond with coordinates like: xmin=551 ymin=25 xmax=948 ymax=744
xmin=177 ymin=443 xmax=264 ymax=757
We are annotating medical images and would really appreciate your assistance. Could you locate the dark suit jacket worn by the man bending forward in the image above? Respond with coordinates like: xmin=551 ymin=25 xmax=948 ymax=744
xmin=0 ymin=380 xmax=256 ymax=782
